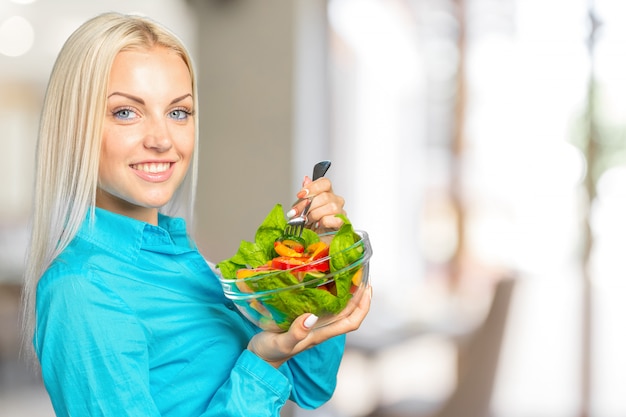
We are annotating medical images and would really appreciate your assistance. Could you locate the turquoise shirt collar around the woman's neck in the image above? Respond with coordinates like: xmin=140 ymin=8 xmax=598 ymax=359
xmin=78 ymin=207 xmax=195 ymax=259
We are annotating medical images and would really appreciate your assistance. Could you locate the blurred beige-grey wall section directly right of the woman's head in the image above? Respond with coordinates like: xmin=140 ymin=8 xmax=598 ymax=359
xmin=190 ymin=0 xmax=328 ymax=262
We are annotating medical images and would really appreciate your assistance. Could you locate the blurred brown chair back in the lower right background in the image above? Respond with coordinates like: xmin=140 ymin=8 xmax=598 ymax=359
xmin=360 ymin=277 xmax=515 ymax=417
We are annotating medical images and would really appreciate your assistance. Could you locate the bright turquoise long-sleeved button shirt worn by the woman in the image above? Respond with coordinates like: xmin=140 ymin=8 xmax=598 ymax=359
xmin=34 ymin=209 xmax=345 ymax=417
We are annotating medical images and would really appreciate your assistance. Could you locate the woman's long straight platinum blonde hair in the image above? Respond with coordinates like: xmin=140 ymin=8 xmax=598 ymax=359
xmin=23 ymin=13 xmax=198 ymax=354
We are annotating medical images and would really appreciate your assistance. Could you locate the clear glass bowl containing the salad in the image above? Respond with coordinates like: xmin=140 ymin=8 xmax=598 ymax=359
xmin=217 ymin=230 xmax=372 ymax=332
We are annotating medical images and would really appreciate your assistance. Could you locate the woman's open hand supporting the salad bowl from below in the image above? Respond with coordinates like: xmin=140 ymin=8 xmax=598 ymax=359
xmin=248 ymin=286 xmax=372 ymax=368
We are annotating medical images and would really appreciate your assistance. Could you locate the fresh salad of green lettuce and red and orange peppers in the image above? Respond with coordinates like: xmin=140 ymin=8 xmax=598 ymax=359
xmin=217 ymin=204 xmax=365 ymax=330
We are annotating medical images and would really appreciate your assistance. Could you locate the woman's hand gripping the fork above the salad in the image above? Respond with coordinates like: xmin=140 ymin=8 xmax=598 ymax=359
xmin=287 ymin=176 xmax=346 ymax=232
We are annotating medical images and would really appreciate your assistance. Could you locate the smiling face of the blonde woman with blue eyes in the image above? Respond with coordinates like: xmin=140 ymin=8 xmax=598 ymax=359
xmin=96 ymin=47 xmax=195 ymax=224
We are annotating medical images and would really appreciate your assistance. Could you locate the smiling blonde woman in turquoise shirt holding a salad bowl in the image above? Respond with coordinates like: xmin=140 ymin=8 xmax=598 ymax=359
xmin=25 ymin=13 xmax=371 ymax=417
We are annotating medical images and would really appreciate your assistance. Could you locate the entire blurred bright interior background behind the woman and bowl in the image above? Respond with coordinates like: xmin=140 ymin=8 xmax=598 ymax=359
xmin=0 ymin=0 xmax=626 ymax=417
